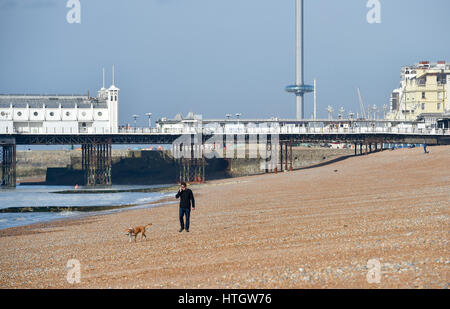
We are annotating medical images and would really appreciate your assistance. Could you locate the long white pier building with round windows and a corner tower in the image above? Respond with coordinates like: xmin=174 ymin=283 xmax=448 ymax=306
xmin=0 ymin=76 xmax=119 ymax=134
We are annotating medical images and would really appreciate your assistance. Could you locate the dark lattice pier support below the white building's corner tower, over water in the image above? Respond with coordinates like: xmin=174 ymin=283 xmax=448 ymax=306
xmin=82 ymin=140 xmax=112 ymax=186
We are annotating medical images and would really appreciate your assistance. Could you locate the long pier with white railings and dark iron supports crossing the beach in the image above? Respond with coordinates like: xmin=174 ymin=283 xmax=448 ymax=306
xmin=0 ymin=119 xmax=450 ymax=187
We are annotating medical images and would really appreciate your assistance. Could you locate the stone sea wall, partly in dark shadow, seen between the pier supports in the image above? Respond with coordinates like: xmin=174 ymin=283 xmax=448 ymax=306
xmin=4 ymin=147 xmax=354 ymax=185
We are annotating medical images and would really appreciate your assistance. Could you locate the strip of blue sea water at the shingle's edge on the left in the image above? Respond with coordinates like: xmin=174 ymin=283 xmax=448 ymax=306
xmin=0 ymin=185 xmax=173 ymax=230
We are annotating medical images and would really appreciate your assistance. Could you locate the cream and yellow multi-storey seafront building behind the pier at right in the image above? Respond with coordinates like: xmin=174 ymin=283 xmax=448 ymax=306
xmin=387 ymin=61 xmax=450 ymax=127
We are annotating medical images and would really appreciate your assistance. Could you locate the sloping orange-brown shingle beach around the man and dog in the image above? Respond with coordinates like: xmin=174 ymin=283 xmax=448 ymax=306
xmin=0 ymin=146 xmax=450 ymax=288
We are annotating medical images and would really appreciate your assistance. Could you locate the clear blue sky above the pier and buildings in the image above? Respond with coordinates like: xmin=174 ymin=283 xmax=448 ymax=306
xmin=0 ymin=0 xmax=450 ymax=125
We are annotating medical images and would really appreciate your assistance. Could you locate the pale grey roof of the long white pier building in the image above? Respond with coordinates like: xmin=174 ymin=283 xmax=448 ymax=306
xmin=0 ymin=94 xmax=108 ymax=108
